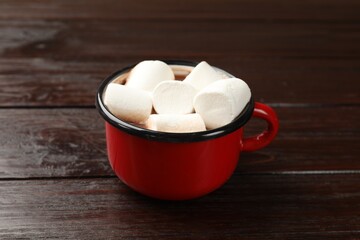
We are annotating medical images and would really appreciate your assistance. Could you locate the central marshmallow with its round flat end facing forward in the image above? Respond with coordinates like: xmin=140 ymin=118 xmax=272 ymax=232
xmin=153 ymin=80 xmax=196 ymax=114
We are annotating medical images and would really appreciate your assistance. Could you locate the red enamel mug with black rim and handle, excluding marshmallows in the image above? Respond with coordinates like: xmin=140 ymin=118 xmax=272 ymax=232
xmin=96 ymin=60 xmax=279 ymax=200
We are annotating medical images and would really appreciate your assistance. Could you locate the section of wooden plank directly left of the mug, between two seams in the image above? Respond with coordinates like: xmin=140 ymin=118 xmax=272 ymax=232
xmin=0 ymin=109 xmax=111 ymax=177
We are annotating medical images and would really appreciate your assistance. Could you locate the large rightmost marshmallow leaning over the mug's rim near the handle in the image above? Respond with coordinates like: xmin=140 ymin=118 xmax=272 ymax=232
xmin=194 ymin=78 xmax=251 ymax=129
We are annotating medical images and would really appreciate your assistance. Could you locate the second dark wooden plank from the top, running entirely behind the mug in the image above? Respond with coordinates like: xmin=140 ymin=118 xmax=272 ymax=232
xmin=0 ymin=19 xmax=360 ymax=61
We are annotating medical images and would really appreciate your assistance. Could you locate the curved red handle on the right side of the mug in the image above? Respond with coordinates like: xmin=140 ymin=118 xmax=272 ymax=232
xmin=242 ymin=102 xmax=279 ymax=152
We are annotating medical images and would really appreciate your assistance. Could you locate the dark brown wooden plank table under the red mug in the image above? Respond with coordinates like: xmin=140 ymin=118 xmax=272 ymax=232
xmin=0 ymin=0 xmax=360 ymax=239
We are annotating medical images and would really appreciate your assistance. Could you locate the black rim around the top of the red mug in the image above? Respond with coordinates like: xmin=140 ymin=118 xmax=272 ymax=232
xmin=95 ymin=60 xmax=255 ymax=142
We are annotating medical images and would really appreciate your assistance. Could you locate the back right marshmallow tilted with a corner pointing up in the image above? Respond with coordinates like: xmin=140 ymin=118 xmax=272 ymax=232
xmin=184 ymin=61 xmax=223 ymax=91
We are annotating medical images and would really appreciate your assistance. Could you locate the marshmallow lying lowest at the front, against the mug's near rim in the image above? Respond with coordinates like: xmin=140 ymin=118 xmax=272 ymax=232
xmin=147 ymin=113 xmax=206 ymax=133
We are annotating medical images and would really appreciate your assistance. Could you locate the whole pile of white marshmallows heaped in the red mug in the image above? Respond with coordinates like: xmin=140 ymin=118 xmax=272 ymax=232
xmin=104 ymin=60 xmax=251 ymax=133
